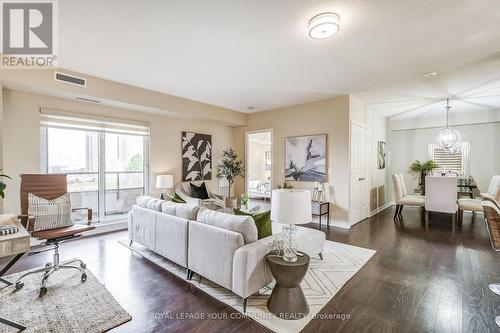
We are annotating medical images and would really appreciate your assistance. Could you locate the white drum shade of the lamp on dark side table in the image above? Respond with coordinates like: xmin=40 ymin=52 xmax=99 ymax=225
xmin=271 ymin=189 xmax=312 ymax=224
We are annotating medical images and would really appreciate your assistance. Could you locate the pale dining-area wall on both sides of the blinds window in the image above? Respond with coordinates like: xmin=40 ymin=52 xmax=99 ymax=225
xmin=389 ymin=113 xmax=500 ymax=197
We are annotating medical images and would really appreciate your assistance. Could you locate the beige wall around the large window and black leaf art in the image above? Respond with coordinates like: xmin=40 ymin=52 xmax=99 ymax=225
xmin=0 ymin=90 xmax=233 ymax=213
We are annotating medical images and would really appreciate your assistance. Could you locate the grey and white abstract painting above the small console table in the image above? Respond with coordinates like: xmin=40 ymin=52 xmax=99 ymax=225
xmin=285 ymin=134 xmax=327 ymax=182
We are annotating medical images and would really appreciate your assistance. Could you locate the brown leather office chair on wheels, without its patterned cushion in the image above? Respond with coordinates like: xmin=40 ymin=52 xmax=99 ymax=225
xmin=16 ymin=174 xmax=95 ymax=296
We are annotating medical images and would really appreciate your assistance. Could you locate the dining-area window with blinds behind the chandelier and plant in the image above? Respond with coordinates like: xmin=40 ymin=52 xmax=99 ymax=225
xmin=429 ymin=142 xmax=470 ymax=176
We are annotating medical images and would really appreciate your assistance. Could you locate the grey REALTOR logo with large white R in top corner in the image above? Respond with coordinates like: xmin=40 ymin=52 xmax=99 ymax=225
xmin=2 ymin=0 xmax=57 ymax=68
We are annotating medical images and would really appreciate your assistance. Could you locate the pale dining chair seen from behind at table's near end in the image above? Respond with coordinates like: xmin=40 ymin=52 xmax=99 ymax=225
xmin=425 ymin=176 xmax=458 ymax=232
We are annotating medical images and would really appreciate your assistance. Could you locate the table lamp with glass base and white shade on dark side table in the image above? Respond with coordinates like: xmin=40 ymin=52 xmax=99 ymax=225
xmin=271 ymin=189 xmax=312 ymax=262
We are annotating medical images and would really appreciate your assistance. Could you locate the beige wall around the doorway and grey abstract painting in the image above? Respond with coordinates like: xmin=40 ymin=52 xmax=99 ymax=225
xmin=235 ymin=96 xmax=349 ymax=227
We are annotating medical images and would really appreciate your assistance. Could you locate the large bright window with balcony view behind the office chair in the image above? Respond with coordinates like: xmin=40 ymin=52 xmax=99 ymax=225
xmin=41 ymin=114 xmax=149 ymax=222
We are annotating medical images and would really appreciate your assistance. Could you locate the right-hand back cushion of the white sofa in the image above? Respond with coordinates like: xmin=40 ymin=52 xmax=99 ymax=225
xmin=196 ymin=207 xmax=258 ymax=244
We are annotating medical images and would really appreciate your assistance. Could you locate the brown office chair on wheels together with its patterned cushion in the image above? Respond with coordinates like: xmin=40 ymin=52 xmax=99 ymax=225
xmin=15 ymin=174 xmax=95 ymax=296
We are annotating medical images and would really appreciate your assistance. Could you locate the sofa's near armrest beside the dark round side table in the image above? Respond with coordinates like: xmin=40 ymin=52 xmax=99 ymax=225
xmin=233 ymin=236 xmax=273 ymax=298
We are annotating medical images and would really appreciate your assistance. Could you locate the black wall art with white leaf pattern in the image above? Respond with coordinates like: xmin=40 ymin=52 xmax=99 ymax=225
xmin=181 ymin=132 xmax=212 ymax=181
